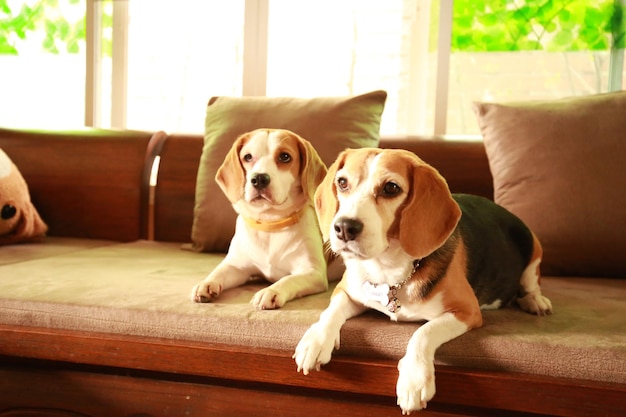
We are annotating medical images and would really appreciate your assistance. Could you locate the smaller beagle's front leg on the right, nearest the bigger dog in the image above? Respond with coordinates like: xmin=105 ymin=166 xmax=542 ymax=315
xmin=250 ymin=271 xmax=328 ymax=310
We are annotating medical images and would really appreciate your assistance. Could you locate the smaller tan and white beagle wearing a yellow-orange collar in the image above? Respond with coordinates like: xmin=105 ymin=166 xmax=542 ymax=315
xmin=191 ymin=129 xmax=328 ymax=309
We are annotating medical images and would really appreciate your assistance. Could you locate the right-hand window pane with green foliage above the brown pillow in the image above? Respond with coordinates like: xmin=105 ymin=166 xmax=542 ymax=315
xmin=447 ymin=0 xmax=626 ymax=134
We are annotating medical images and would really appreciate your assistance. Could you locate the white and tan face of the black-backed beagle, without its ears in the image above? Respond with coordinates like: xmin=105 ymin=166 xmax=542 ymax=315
xmin=330 ymin=151 xmax=410 ymax=259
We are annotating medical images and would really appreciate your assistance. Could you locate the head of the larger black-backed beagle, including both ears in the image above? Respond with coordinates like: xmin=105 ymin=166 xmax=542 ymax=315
xmin=315 ymin=149 xmax=461 ymax=259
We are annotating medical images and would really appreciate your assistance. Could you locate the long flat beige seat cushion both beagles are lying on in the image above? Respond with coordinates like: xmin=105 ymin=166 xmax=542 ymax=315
xmin=0 ymin=237 xmax=626 ymax=383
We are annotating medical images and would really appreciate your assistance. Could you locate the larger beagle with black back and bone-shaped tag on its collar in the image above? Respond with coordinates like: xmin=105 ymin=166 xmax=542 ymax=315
xmin=293 ymin=149 xmax=552 ymax=414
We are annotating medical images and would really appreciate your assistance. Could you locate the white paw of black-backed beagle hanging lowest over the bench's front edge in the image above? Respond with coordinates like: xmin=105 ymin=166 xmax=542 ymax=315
xmin=396 ymin=356 xmax=435 ymax=415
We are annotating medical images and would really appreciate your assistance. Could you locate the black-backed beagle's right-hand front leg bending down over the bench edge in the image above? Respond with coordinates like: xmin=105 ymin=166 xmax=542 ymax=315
xmin=396 ymin=313 xmax=470 ymax=415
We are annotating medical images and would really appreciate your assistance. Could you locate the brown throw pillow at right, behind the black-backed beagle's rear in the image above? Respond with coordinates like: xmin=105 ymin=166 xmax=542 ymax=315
xmin=475 ymin=92 xmax=626 ymax=278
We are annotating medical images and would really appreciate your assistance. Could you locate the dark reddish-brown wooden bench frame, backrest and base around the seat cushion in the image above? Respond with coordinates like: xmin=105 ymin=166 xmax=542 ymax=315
xmin=0 ymin=130 xmax=626 ymax=417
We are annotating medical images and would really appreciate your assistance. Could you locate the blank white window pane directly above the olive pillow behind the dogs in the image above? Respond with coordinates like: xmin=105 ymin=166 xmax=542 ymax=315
xmin=266 ymin=0 xmax=417 ymax=133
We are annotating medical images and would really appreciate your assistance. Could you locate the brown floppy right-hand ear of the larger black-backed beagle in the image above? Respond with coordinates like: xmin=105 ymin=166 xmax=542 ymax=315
xmin=399 ymin=156 xmax=461 ymax=259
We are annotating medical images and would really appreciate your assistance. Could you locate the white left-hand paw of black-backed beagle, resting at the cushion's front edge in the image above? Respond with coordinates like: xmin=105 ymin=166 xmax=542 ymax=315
xmin=292 ymin=322 xmax=339 ymax=375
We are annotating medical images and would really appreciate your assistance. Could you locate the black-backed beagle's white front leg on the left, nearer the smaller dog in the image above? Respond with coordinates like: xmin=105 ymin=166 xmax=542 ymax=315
xmin=293 ymin=288 xmax=365 ymax=375
